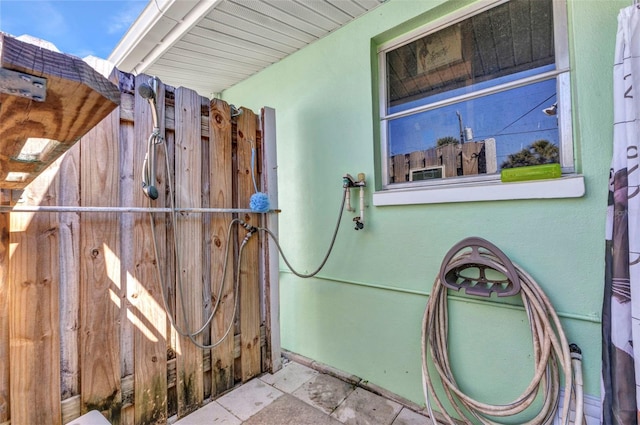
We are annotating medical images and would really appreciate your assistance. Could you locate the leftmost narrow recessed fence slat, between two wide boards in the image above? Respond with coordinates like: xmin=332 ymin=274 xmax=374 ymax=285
xmin=58 ymin=144 xmax=80 ymax=400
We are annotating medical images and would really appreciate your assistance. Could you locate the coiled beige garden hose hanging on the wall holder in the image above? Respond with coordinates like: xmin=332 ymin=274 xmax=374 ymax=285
xmin=422 ymin=247 xmax=584 ymax=425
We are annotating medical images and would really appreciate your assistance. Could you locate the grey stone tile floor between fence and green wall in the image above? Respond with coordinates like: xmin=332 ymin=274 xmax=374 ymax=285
xmin=174 ymin=361 xmax=431 ymax=425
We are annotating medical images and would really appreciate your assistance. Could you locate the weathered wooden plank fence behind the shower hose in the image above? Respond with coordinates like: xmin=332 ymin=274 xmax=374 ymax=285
xmin=0 ymin=70 xmax=279 ymax=425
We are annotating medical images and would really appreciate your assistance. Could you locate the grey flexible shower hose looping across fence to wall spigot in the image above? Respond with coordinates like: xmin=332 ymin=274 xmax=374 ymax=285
xmin=148 ymin=133 xmax=348 ymax=350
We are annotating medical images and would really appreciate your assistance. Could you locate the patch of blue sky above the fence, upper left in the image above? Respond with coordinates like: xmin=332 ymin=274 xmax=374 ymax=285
xmin=0 ymin=0 xmax=149 ymax=59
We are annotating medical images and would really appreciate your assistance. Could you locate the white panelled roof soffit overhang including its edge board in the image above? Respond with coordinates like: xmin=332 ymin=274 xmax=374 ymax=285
xmin=109 ymin=0 xmax=386 ymax=97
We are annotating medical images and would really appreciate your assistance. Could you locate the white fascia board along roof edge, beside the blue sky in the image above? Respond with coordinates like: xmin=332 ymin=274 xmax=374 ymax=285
xmin=109 ymin=0 xmax=222 ymax=74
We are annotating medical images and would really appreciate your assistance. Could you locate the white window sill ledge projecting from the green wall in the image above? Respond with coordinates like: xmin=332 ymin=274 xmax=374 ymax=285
xmin=373 ymin=175 xmax=585 ymax=206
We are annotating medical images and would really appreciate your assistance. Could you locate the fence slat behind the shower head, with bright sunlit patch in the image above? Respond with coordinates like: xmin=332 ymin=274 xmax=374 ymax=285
xmin=132 ymin=75 xmax=167 ymax=425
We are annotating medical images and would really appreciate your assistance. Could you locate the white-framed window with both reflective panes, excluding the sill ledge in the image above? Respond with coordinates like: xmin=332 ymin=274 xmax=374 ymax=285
xmin=374 ymin=0 xmax=574 ymax=201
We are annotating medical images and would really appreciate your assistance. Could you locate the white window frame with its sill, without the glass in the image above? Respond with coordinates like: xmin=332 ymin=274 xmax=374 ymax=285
xmin=373 ymin=0 xmax=585 ymax=206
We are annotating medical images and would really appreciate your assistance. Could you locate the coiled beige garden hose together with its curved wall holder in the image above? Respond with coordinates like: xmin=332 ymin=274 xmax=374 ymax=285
xmin=422 ymin=237 xmax=584 ymax=425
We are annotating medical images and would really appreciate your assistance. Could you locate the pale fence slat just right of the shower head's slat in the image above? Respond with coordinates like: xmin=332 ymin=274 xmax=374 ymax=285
xmin=175 ymin=87 xmax=203 ymax=417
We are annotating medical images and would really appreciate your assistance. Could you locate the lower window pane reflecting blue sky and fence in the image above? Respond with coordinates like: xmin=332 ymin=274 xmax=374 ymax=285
xmin=388 ymin=79 xmax=559 ymax=183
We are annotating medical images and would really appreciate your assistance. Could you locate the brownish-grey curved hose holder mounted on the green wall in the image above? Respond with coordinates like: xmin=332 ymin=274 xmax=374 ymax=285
xmin=440 ymin=237 xmax=520 ymax=297
